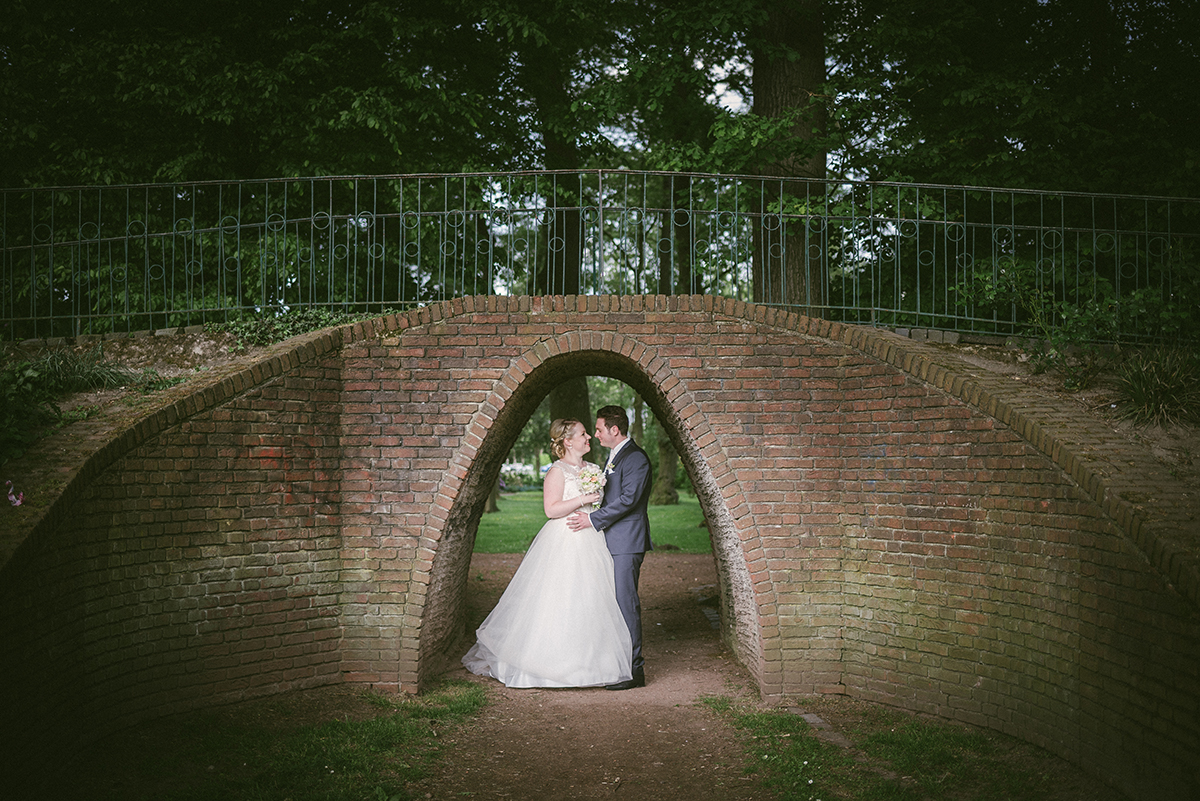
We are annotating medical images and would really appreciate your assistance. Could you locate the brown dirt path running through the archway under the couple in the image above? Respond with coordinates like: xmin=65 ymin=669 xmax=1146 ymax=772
xmin=415 ymin=553 xmax=769 ymax=801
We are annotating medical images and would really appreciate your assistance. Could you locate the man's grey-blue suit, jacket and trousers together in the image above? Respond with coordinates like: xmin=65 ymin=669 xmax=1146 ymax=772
xmin=589 ymin=440 xmax=653 ymax=676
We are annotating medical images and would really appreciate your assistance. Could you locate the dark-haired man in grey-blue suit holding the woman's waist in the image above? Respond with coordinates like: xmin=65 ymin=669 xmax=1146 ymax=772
xmin=566 ymin=406 xmax=653 ymax=689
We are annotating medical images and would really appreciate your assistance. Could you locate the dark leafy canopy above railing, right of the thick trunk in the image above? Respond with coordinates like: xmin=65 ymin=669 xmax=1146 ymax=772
xmin=829 ymin=0 xmax=1200 ymax=195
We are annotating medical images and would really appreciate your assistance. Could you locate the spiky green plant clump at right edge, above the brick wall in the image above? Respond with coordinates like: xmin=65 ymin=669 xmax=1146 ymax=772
xmin=1116 ymin=348 xmax=1200 ymax=427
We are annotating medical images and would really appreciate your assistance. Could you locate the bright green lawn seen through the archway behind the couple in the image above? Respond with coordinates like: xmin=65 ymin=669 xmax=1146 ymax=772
xmin=475 ymin=492 xmax=713 ymax=554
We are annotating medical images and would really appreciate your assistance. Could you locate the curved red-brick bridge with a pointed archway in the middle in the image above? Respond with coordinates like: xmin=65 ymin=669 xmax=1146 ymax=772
xmin=0 ymin=296 xmax=1200 ymax=799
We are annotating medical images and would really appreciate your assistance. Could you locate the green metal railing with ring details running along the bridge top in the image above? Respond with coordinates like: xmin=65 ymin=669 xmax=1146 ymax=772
xmin=0 ymin=170 xmax=1200 ymax=341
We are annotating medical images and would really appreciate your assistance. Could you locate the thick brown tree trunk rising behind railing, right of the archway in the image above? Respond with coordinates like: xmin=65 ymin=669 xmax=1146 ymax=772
xmin=751 ymin=0 xmax=827 ymax=317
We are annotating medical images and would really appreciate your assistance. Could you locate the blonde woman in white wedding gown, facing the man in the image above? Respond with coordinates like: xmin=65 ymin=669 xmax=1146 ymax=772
xmin=462 ymin=420 xmax=632 ymax=687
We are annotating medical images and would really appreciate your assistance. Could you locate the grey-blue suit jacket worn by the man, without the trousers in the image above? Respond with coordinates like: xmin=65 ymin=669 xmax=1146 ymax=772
xmin=590 ymin=440 xmax=653 ymax=554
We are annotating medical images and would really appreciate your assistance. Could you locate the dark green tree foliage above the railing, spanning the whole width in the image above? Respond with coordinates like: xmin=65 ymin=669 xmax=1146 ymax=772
xmin=0 ymin=0 xmax=1200 ymax=197
